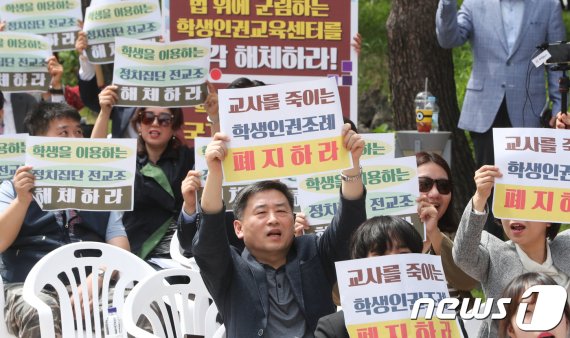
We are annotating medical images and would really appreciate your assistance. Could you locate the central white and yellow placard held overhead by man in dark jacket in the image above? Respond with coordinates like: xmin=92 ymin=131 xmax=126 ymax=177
xmin=219 ymin=78 xmax=352 ymax=183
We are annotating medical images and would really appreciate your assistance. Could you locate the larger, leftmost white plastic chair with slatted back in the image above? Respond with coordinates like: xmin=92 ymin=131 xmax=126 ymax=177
xmin=23 ymin=242 xmax=154 ymax=338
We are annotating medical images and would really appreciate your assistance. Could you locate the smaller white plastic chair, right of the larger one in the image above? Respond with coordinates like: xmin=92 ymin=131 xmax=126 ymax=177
xmin=123 ymin=268 xmax=225 ymax=338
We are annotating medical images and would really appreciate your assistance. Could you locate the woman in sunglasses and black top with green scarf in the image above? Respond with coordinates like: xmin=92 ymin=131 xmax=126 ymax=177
xmin=91 ymin=85 xmax=195 ymax=258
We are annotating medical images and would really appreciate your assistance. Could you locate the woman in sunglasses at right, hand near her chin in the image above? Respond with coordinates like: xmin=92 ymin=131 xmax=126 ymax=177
xmin=410 ymin=152 xmax=478 ymax=322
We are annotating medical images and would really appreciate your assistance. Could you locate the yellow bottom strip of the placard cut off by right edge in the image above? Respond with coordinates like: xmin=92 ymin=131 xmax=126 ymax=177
xmin=493 ymin=184 xmax=570 ymax=223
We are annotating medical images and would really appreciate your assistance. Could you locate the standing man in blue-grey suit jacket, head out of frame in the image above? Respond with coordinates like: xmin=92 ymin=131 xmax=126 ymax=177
xmin=436 ymin=0 xmax=566 ymax=168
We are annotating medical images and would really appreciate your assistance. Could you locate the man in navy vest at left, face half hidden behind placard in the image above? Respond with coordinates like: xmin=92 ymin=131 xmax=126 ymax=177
xmin=0 ymin=102 xmax=130 ymax=338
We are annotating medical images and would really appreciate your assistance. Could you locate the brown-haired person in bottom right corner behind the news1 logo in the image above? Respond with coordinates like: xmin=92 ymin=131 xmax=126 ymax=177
xmin=499 ymin=272 xmax=570 ymax=338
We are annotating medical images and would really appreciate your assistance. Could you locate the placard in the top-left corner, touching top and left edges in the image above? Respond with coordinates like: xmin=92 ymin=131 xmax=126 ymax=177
xmin=0 ymin=0 xmax=83 ymax=51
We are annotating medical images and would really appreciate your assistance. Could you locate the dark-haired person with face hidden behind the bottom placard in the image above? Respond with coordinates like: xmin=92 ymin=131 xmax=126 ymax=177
xmin=315 ymin=216 xmax=423 ymax=338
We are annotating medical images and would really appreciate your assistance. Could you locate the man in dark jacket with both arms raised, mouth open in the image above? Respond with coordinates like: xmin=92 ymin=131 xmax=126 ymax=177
xmin=193 ymin=124 xmax=366 ymax=337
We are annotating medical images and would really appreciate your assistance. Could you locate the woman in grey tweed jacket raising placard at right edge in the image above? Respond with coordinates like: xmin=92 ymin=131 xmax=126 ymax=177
xmin=453 ymin=165 xmax=570 ymax=337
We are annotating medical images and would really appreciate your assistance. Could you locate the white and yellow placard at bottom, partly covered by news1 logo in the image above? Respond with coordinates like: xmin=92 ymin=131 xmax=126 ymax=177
xmin=335 ymin=254 xmax=462 ymax=338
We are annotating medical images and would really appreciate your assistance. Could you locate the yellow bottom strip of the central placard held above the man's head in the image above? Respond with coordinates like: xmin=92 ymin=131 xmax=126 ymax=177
xmin=223 ymin=136 xmax=350 ymax=182
